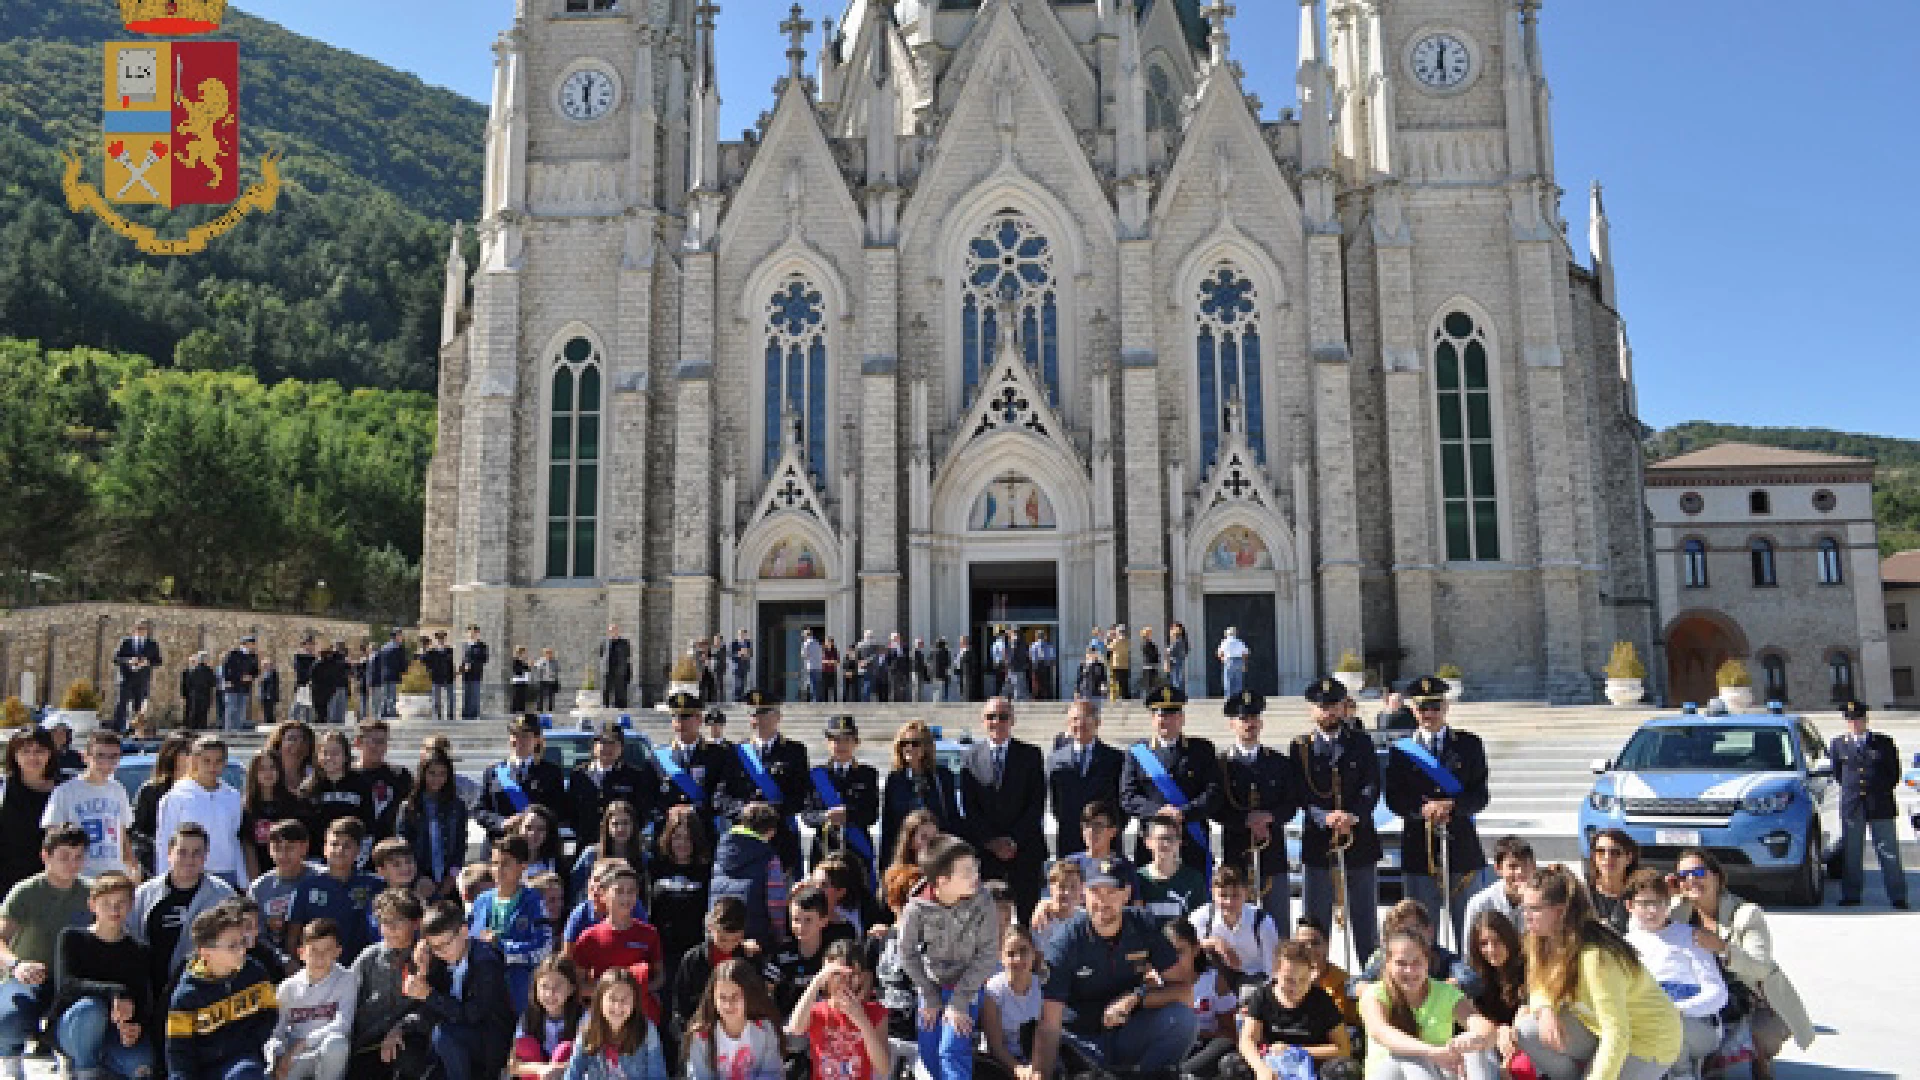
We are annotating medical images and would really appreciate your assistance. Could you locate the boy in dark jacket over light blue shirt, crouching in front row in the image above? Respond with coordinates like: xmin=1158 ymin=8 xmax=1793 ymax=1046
xmin=416 ymin=901 xmax=515 ymax=1080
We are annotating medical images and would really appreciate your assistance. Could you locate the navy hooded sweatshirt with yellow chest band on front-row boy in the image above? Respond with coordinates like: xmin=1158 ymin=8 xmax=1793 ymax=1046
xmin=167 ymin=959 xmax=280 ymax=1080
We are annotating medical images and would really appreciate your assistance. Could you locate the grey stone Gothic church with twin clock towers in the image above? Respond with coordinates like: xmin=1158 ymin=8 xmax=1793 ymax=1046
xmin=422 ymin=0 xmax=1653 ymax=701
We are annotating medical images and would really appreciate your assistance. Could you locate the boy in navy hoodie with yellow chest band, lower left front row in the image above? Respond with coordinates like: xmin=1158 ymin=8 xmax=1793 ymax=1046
xmin=167 ymin=905 xmax=280 ymax=1080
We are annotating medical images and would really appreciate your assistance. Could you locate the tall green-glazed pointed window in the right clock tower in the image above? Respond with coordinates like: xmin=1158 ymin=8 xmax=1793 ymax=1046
xmin=1434 ymin=311 xmax=1500 ymax=561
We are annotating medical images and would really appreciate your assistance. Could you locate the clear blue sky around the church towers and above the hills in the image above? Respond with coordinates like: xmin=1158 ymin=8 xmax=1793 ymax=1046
xmin=238 ymin=0 xmax=1920 ymax=438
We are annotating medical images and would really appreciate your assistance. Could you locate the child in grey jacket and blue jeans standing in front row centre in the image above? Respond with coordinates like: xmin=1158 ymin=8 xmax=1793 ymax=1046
xmin=900 ymin=836 xmax=1000 ymax=1080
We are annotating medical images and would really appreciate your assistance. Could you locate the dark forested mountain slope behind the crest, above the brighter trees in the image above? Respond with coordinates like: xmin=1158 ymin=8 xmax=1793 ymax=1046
xmin=0 ymin=0 xmax=486 ymax=390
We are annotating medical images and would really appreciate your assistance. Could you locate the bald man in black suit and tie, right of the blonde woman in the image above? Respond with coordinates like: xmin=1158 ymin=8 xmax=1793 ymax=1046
xmin=960 ymin=698 xmax=1052 ymax=924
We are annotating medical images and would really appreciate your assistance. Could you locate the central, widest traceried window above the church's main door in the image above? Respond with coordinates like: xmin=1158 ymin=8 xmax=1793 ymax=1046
xmin=960 ymin=209 xmax=1060 ymax=404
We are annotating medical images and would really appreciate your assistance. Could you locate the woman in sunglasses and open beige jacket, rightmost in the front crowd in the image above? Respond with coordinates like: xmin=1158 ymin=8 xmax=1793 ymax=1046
xmin=1668 ymin=847 xmax=1814 ymax=1080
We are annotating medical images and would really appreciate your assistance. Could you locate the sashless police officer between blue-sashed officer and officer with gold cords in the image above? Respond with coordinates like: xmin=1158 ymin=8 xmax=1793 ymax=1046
xmin=1219 ymin=690 xmax=1300 ymax=926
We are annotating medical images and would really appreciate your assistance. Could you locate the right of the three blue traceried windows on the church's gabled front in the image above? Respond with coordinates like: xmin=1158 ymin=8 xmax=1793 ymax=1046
xmin=1194 ymin=263 xmax=1267 ymax=465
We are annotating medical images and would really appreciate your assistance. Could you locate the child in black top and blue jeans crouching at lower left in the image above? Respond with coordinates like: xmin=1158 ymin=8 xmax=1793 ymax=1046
xmin=50 ymin=868 xmax=156 ymax=1078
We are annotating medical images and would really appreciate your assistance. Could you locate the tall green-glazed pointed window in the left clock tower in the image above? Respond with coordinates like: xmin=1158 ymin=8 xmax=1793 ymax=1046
xmin=547 ymin=338 xmax=601 ymax=578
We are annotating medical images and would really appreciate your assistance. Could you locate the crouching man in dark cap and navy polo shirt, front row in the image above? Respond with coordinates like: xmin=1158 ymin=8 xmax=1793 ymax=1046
xmin=1033 ymin=859 xmax=1198 ymax=1076
